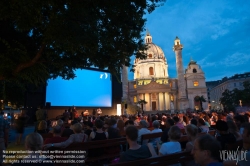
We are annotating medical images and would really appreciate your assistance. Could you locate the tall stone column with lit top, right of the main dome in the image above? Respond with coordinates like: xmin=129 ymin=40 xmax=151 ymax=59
xmin=173 ymin=37 xmax=189 ymax=110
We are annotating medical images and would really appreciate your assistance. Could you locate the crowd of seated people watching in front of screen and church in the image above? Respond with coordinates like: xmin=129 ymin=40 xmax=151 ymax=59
xmin=6 ymin=109 xmax=250 ymax=165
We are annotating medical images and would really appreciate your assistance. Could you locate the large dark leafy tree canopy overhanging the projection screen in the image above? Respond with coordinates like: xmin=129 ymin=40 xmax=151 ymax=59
xmin=0 ymin=0 xmax=164 ymax=86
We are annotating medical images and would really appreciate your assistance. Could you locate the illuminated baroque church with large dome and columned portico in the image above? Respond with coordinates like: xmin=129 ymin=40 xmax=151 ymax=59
xmin=122 ymin=32 xmax=208 ymax=112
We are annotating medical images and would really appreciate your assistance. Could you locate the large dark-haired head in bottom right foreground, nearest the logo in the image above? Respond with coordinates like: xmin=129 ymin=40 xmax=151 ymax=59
xmin=192 ymin=134 xmax=221 ymax=166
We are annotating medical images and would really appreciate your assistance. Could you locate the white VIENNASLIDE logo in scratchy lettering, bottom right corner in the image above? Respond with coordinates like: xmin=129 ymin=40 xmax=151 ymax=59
xmin=220 ymin=147 xmax=247 ymax=165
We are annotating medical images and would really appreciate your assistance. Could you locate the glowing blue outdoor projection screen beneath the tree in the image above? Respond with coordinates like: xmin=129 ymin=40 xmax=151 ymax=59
xmin=46 ymin=69 xmax=112 ymax=107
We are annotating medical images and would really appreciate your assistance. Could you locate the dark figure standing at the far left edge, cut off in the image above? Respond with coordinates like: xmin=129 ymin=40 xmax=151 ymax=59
xmin=0 ymin=112 xmax=10 ymax=163
